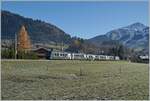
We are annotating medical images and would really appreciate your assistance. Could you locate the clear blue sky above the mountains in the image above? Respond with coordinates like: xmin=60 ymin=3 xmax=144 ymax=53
xmin=2 ymin=1 xmax=148 ymax=38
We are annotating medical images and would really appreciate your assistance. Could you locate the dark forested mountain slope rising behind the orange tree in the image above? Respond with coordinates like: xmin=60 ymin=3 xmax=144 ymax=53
xmin=1 ymin=11 xmax=71 ymax=44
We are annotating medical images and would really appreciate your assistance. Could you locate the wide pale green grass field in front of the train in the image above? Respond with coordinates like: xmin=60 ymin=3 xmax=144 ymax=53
xmin=1 ymin=60 xmax=149 ymax=100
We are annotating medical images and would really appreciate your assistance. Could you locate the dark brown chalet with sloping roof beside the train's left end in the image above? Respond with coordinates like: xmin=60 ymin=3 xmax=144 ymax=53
xmin=32 ymin=48 xmax=53 ymax=59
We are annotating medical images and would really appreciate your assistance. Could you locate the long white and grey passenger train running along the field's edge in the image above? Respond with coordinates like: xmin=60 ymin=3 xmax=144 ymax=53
xmin=49 ymin=51 xmax=120 ymax=60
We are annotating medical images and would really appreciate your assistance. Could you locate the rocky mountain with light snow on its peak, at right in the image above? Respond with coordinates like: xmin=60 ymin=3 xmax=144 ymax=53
xmin=89 ymin=22 xmax=149 ymax=52
